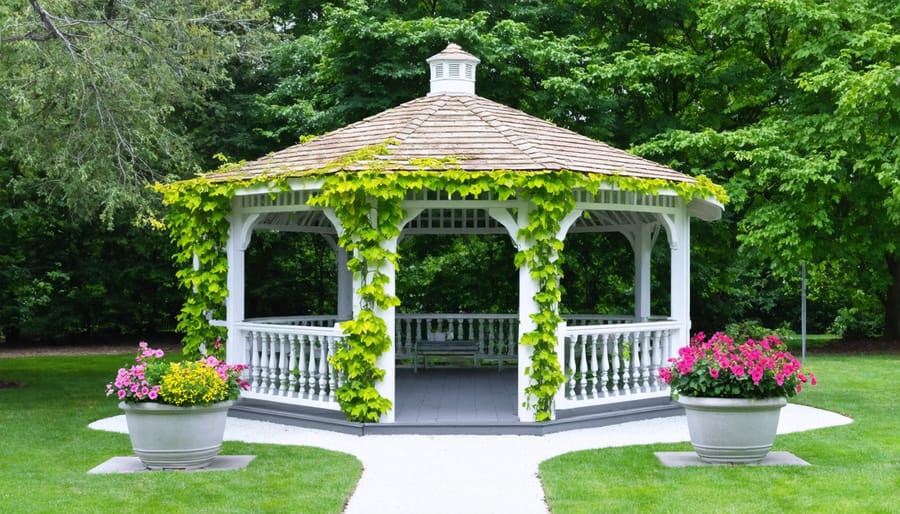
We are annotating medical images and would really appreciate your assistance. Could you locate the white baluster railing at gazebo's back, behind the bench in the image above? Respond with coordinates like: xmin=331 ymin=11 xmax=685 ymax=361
xmin=395 ymin=313 xmax=519 ymax=361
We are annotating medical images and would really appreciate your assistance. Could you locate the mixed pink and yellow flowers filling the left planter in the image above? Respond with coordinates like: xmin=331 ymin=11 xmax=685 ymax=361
xmin=106 ymin=341 xmax=250 ymax=407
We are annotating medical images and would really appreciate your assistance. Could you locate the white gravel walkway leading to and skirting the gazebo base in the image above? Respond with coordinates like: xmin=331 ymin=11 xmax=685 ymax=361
xmin=90 ymin=404 xmax=852 ymax=514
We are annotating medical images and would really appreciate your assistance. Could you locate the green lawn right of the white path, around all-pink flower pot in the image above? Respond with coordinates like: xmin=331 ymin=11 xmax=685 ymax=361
xmin=540 ymin=355 xmax=900 ymax=514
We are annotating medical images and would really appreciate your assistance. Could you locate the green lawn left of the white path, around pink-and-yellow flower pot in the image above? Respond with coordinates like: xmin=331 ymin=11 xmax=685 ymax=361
xmin=0 ymin=355 xmax=362 ymax=514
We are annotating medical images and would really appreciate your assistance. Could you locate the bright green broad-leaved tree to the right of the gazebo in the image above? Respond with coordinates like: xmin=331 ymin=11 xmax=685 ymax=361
xmin=638 ymin=1 xmax=900 ymax=339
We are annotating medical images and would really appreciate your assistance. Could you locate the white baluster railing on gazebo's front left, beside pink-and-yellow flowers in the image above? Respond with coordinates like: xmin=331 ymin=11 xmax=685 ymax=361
xmin=236 ymin=323 xmax=344 ymax=410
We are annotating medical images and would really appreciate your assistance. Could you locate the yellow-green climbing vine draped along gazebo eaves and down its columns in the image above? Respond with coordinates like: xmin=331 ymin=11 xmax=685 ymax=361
xmin=156 ymin=141 xmax=727 ymax=416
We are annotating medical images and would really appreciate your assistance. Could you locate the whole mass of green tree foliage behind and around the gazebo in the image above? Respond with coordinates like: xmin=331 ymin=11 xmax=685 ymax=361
xmin=0 ymin=0 xmax=900 ymax=344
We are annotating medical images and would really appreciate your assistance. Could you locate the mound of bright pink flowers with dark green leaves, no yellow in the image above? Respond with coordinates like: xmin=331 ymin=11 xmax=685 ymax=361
xmin=659 ymin=332 xmax=816 ymax=399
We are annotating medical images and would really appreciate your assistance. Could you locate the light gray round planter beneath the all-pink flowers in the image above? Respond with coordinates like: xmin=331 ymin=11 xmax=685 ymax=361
xmin=678 ymin=396 xmax=787 ymax=464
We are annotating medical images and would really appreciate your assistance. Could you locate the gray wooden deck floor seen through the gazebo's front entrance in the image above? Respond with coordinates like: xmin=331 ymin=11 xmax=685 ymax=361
xmin=396 ymin=367 xmax=518 ymax=424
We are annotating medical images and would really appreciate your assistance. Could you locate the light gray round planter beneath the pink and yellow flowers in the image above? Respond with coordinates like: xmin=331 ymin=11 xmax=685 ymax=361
xmin=119 ymin=401 xmax=234 ymax=469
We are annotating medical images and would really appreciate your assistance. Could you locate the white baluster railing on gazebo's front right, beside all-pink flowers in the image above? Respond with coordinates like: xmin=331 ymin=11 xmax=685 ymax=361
xmin=556 ymin=321 xmax=680 ymax=409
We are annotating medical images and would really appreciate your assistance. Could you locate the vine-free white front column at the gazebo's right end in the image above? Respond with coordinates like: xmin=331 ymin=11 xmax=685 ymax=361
xmin=669 ymin=204 xmax=691 ymax=356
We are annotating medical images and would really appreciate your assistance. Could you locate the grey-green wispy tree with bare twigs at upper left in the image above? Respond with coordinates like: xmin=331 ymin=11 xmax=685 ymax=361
xmin=0 ymin=0 xmax=265 ymax=221
